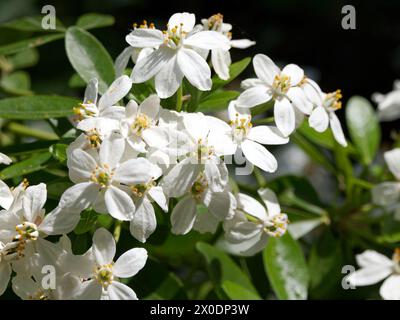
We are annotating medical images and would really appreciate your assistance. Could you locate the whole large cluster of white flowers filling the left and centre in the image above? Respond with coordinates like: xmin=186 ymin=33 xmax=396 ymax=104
xmin=0 ymin=13 xmax=354 ymax=299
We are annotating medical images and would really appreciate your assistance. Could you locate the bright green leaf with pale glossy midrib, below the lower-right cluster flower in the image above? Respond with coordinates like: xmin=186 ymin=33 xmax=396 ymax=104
xmin=263 ymin=232 xmax=309 ymax=300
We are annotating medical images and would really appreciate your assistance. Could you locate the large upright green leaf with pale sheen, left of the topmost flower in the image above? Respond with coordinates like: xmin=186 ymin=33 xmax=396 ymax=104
xmin=65 ymin=27 xmax=115 ymax=94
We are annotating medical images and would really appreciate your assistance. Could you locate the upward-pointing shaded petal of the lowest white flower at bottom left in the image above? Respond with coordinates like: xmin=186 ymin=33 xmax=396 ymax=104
xmin=92 ymin=228 xmax=116 ymax=266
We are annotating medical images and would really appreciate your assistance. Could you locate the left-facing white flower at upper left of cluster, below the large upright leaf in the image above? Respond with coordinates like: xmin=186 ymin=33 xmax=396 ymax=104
xmin=74 ymin=76 xmax=132 ymax=134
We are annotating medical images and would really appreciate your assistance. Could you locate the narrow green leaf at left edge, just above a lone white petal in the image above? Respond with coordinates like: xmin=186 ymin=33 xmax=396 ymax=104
xmin=0 ymin=152 xmax=51 ymax=180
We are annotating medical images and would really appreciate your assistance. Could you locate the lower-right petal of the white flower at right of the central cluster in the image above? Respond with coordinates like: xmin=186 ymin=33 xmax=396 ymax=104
xmin=241 ymin=139 xmax=278 ymax=172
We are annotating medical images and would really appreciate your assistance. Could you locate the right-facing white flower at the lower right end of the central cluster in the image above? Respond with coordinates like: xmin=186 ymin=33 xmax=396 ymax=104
xmin=224 ymin=189 xmax=288 ymax=256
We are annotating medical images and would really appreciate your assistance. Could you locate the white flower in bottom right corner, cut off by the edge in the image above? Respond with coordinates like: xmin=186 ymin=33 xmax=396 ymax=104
xmin=346 ymin=249 xmax=400 ymax=300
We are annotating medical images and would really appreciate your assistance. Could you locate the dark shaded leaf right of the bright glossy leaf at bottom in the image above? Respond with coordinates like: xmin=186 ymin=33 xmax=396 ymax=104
xmin=308 ymin=229 xmax=344 ymax=299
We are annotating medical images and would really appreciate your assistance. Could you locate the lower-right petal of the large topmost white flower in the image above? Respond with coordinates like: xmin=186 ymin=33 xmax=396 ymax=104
xmin=177 ymin=48 xmax=212 ymax=91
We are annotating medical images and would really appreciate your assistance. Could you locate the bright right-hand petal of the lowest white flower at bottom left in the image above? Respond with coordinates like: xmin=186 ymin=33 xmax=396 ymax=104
xmin=113 ymin=248 xmax=147 ymax=278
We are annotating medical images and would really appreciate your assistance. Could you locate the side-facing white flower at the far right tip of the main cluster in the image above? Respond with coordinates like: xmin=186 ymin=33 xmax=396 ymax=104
xmin=306 ymin=79 xmax=347 ymax=147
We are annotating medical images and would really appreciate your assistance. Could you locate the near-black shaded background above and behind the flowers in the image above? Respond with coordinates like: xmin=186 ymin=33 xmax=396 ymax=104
xmin=0 ymin=0 xmax=400 ymax=136
